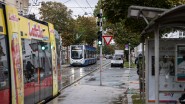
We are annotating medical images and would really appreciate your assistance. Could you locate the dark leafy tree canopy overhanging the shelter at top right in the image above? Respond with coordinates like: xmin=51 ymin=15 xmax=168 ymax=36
xmin=102 ymin=0 xmax=185 ymax=34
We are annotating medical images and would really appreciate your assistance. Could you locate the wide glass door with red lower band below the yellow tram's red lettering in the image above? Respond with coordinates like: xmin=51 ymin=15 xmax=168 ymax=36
xmin=22 ymin=39 xmax=52 ymax=104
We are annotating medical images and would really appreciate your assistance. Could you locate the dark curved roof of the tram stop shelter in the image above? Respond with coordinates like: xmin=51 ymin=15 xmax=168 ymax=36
xmin=141 ymin=4 xmax=185 ymax=35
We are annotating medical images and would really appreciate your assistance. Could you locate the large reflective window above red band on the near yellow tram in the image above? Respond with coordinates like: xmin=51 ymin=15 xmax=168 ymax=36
xmin=22 ymin=39 xmax=52 ymax=83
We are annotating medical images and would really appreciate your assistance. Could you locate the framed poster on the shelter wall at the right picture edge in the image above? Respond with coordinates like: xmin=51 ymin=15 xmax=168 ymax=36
xmin=176 ymin=44 xmax=185 ymax=82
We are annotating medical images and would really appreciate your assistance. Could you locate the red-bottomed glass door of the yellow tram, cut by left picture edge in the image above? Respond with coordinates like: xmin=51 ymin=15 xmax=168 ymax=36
xmin=0 ymin=34 xmax=10 ymax=104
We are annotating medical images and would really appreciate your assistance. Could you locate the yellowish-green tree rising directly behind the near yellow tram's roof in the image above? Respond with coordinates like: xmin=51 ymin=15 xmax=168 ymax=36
xmin=40 ymin=1 xmax=75 ymax=46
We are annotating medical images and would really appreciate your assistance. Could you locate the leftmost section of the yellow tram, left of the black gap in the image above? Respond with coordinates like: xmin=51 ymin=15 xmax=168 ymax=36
xmin=0 ymin=4 xmax=11 ymax=104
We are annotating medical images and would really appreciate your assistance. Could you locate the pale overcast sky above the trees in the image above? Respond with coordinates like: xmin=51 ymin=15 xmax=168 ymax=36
xmin=28 ymin=0 xmax=98 ymax=18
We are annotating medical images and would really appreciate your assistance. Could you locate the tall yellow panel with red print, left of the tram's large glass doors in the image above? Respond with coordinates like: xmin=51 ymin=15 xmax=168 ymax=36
xmin=6 ymin=5 xmax=24 ymax=104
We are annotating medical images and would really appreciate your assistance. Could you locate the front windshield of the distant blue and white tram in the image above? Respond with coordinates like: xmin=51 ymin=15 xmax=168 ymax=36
xmin=71 ymin=46 xmax=83 ymax=59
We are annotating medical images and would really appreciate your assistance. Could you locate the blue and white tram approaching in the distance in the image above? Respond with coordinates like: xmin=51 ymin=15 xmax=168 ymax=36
xmin=70 ymin=45 xmax=97 ymax=66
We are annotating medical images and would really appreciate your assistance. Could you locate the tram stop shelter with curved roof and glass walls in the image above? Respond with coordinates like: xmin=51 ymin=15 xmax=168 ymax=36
xmin=129 ymin=5 xmax=185 ymax=104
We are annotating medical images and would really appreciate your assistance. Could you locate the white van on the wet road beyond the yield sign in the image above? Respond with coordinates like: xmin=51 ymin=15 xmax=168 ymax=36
xmin=111 ymin=54 xmax=124 ymax=68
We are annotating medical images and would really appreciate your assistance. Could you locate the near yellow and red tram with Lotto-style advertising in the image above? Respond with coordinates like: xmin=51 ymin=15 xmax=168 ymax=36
xmin=0 ymin=4 xmax=60 ymax=104
